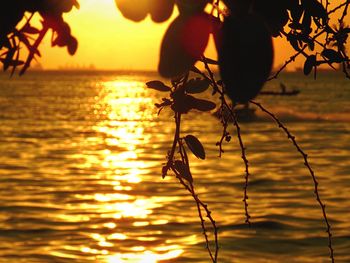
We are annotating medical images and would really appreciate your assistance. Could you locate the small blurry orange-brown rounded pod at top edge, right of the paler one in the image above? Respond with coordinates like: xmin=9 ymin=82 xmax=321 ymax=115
xmin=149 ymin=0 xmax=175 ymax=23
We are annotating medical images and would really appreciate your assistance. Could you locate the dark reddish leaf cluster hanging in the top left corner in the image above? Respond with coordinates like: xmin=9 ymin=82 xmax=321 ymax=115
xmin=0 ymin=0 xmax=79 ymax=74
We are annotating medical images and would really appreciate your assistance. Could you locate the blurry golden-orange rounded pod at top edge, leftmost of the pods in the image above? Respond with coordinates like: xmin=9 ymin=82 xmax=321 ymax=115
xmin=115 ymin=0 xmax=149 ymax=22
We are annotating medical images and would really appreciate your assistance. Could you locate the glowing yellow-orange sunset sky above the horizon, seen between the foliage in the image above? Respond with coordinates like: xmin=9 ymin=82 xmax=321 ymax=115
xmin=34 ymin=0 xmax=349 ymax=70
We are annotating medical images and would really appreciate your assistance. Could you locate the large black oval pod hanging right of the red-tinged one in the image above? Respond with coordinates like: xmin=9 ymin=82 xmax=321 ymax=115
xmin=215 ymin=15 xmax=273 ymax=103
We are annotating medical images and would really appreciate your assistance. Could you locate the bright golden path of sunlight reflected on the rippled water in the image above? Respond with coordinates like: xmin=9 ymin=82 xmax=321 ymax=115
xmin=77 ymin=78 xmax=183 ymax=263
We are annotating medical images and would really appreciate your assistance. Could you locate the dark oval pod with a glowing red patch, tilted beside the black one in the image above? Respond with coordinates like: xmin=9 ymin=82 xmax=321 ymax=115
xmin=158 ymin=13 xmax=211 ymax=78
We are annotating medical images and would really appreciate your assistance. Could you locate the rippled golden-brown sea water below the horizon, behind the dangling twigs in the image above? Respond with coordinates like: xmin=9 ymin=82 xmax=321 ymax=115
xmin=0 ymin=72 xmax=350 ymax=263
